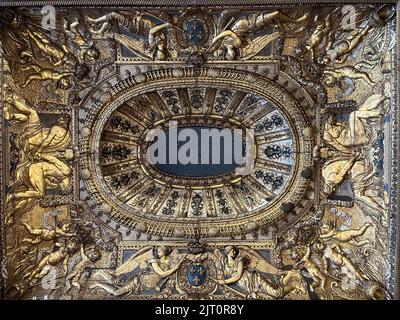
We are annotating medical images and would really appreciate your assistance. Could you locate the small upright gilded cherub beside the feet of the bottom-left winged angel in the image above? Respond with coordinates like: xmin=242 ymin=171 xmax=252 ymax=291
xmin=65 ymin=245 xmax=101 ymax=292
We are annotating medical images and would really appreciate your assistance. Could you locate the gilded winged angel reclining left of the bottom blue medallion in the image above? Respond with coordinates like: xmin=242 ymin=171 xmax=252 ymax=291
xmin=90 ymin=246 xmax=186 ymax=296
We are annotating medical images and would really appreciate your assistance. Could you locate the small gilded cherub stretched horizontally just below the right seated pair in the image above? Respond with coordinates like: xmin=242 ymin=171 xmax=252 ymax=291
xmin=319 ymin=222 xmax=372 ymax=246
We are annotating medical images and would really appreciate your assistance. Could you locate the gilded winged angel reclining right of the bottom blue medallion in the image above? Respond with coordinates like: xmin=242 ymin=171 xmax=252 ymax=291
xmin=214 ymin=246 xmax=308 ymax=299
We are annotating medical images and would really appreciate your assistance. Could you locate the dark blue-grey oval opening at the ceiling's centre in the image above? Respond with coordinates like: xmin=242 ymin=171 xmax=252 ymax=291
xmin=147 ymin=125 xmax=245 ymax=178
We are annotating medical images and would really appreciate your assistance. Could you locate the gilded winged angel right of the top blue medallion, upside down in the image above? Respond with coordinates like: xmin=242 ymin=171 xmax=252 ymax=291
xmin=209 ymin=10 xmax=309 ymax=60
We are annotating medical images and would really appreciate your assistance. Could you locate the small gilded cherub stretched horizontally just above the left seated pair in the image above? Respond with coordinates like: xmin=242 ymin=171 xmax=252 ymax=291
xmin=21 ymin=64 xmax=74 ymax=90
